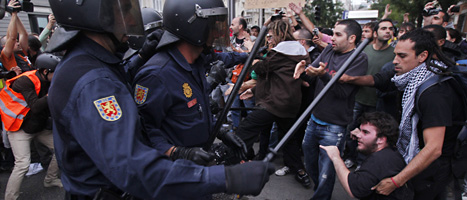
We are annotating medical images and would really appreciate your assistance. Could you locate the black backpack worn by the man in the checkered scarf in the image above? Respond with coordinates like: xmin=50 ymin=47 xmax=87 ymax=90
xmin=415 ymin=65 xmax=467 ymax=178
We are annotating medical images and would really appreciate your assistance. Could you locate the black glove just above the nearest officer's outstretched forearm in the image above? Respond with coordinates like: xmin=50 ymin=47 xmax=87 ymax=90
xmin=170 ymin=147 xmax=215 ymax=165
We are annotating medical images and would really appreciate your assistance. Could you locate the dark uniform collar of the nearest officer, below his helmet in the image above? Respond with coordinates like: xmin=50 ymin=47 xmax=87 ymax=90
xmin=77 ymin=35 xmax=122 ymax=64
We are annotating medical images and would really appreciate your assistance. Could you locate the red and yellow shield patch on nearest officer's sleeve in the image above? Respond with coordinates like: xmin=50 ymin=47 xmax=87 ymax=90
xmin=94 ymin=96 xmax=122 ymax=121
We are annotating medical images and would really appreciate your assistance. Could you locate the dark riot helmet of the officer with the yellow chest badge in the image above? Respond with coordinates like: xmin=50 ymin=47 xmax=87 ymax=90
xmin=163 ymin=0 xmax=229 ymax=48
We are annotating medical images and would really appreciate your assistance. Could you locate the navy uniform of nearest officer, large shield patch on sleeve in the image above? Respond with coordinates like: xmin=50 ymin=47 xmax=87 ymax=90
xmin=49 ymin=35 xmax=226 ymax=199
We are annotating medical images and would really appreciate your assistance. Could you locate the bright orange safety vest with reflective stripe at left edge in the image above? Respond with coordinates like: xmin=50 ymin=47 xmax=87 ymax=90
xmin=0 ymin=70 xmax=41 ymax=131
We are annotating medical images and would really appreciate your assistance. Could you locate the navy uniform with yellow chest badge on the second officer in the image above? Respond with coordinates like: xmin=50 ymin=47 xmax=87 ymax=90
xmin=133 ymin=46 xmax=247 ymax=152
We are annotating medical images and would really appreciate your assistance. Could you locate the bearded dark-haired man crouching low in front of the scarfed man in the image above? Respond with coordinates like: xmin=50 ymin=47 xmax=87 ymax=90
xmin=320 ymin=112 xmax=413 ymax=199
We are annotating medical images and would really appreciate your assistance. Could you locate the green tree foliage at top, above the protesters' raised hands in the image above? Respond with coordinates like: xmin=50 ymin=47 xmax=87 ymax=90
xmin=303 ymin=0 xmax=344 ymax=28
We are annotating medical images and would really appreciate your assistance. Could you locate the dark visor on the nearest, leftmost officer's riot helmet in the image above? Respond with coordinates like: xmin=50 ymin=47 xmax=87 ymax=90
xmin=99 ymin=0 xmax=144 ymax=38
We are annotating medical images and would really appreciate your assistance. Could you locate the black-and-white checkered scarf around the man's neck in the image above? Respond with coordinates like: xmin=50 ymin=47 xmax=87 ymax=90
xmin=391 ymin=62 xmax=444 ymax=163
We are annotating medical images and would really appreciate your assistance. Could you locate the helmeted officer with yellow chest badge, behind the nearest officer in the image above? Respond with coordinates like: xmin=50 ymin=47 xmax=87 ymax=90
xmin=133 ymin=0 xmax=247 ymax=165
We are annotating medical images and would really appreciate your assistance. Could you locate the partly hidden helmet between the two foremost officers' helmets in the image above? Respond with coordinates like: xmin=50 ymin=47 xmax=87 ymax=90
xmin=128 ymin=8 xmax=162 ymax=51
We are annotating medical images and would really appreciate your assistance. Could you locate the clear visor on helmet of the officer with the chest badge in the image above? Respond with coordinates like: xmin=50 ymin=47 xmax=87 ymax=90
xmin=209 ymin=15 xmax=230 ymax=48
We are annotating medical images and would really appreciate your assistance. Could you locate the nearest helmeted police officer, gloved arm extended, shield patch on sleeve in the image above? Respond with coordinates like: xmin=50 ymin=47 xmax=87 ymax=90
xmin=48 ymin=0 xmax=273 ymax=199
